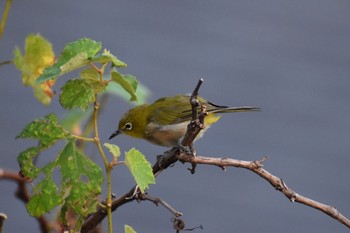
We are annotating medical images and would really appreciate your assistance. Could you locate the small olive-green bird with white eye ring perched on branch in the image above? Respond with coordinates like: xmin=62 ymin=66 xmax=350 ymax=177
xmin=109 ymin=95 xmax=260 ymax=147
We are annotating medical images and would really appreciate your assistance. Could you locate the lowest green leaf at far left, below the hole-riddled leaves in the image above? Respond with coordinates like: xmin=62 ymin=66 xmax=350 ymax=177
xmin=26 ymin=177 xmax=62 ymax=217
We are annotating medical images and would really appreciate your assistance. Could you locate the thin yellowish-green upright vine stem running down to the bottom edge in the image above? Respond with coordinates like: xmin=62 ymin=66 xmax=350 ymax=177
xmin=93 ymin=95 xmax=113 ymax=233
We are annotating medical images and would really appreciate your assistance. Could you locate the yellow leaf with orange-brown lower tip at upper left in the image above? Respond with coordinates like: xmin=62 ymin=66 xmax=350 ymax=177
xmin=13 ymin=34 xmax=55 ymax=105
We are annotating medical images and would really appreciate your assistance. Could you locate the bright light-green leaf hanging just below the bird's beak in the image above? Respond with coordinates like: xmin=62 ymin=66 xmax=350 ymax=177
xmin=125 ymin=148 xmax=155 ymax=193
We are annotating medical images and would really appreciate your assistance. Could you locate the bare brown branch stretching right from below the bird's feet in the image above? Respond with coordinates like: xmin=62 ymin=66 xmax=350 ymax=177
xmin=177 ymin=153 xmax=350 ymax=228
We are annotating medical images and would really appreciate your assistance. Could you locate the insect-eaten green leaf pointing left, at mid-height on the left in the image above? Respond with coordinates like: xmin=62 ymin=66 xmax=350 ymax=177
xmin=16 ymin=113 xmax=70 ymax=147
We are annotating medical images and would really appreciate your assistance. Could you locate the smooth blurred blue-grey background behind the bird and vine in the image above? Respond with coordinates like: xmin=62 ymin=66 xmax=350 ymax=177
xmin=0 ymin=0 xmax=350 ymax=233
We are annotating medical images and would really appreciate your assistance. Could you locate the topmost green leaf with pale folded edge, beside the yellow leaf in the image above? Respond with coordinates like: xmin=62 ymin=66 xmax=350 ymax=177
xmin=37 ymin=38 xmax=102 ymax=82
